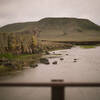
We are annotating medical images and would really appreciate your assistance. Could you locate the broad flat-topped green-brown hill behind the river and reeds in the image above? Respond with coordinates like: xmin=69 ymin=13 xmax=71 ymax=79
xmin=0 ymin=18 xmax=100 ymax=41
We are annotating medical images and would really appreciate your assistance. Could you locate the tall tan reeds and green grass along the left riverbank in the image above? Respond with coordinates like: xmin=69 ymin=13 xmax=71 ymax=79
xmin=0 ymin=32 xmax=72 ymax=75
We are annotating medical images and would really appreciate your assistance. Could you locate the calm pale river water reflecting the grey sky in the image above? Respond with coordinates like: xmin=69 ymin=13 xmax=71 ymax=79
xmin=0 ymin=47 xmax=100 ymax=100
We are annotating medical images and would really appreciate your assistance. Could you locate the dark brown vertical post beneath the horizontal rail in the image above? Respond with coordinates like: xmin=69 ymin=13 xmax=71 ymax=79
xmin=51 ymin=80 xmax=65 ymax=100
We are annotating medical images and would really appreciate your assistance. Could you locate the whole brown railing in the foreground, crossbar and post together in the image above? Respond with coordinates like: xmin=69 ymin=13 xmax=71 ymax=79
xmin=0 ymin=80 xmax=100 ymax=100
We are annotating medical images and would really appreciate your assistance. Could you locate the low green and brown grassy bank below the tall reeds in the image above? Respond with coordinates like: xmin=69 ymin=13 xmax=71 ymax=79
xmin=0 ymin=53 xmax=41 ymax=76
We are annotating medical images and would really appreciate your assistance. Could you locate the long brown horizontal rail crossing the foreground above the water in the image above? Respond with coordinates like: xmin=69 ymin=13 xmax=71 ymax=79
xmin=0 ymin=82 xmax=100 ymax=87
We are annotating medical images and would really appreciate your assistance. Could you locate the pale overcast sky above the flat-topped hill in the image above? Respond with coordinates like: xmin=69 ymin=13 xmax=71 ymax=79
xmin=0 ymin=0 xmax=100 ymax=26
